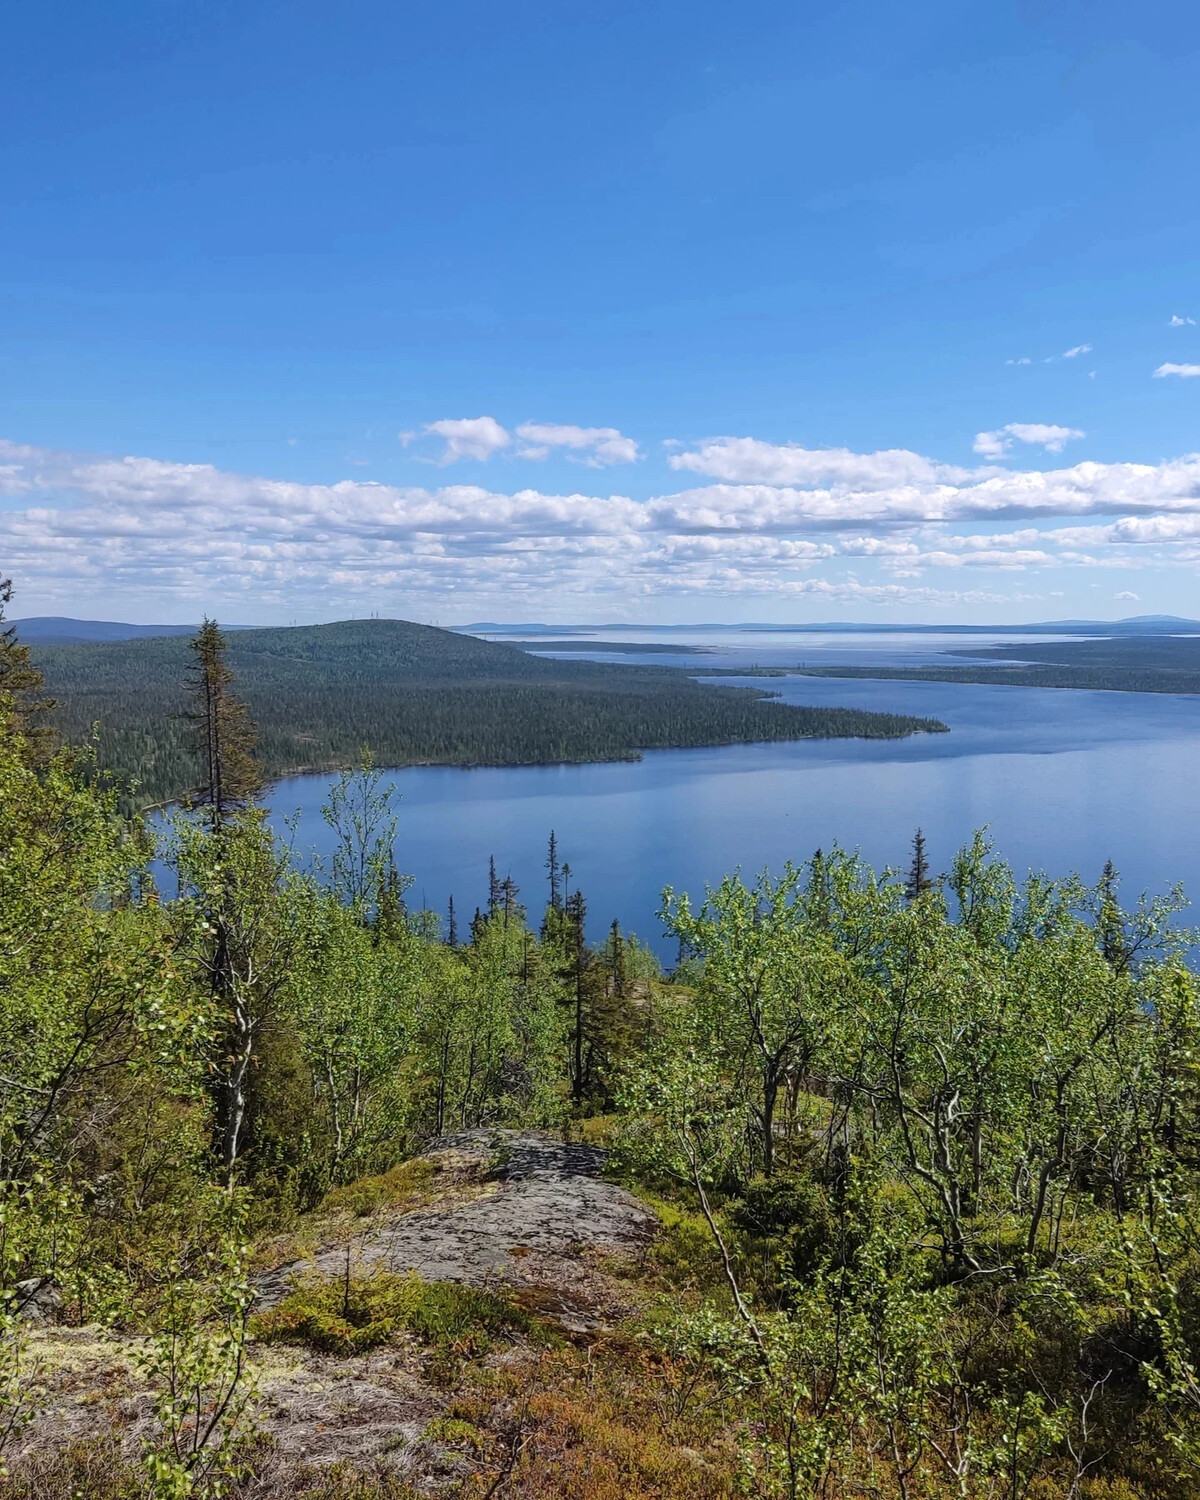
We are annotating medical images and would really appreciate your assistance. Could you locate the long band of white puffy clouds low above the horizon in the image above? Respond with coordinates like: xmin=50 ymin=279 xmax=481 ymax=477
xmin=0 ymin=432 xmax=1200 ymax=618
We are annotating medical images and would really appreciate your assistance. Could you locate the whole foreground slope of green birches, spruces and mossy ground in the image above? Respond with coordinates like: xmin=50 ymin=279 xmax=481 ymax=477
xmin=0 ymin=585 xmax=1200 ymax=1500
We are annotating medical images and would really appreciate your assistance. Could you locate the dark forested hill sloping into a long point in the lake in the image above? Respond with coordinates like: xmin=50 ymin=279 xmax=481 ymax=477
xmin=33 ymin=620 xmax=945 ymax=803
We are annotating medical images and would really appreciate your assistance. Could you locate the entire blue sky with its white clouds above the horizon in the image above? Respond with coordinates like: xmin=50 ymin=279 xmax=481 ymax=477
xmin=0 ymin=0 xmax=1200 ymax=623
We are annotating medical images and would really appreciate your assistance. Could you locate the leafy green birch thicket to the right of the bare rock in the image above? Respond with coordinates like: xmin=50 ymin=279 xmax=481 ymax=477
xmin=621 ymin=836 xmax=1200 ymax=1496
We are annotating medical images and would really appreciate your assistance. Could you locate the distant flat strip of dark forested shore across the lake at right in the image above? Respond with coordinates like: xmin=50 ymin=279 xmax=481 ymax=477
xmin=803 ymin=635 xmax=1200 ymax=693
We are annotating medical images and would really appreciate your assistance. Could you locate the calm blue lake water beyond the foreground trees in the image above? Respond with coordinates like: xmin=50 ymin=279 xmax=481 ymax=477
xmin=259 ymin=638 xmax=1200 ymax=957
